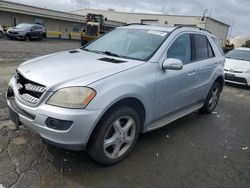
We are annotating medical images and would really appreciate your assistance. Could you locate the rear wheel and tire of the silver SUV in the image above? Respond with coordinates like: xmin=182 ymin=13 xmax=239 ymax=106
xmin=200 ymin=82 xmax=222 ymax=114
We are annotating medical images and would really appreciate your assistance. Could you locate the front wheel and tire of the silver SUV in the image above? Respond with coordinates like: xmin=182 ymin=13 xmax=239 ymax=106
xmin=88 ymin=106 xmax=140 ymax=165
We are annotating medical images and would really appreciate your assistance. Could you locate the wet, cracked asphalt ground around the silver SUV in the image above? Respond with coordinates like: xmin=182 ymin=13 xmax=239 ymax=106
xmin=0 ymin=39 xmax=250 ymax=188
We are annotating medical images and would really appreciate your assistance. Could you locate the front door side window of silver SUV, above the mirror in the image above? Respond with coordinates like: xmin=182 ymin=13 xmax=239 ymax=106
xmin=167 ymin=34 xmax=191 ymax=64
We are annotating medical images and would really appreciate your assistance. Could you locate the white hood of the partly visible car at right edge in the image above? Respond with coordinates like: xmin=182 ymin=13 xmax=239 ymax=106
xmin=225 ymin=58 xmax=250 ymax=72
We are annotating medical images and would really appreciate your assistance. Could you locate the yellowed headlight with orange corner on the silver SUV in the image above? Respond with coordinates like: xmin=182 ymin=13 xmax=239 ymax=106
xmin=46 ymin=87 xmax=96 ymax=108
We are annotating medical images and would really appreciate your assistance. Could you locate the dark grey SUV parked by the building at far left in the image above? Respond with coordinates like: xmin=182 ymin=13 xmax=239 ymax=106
xmin=6 ymin=23 xmax=47 ymax=40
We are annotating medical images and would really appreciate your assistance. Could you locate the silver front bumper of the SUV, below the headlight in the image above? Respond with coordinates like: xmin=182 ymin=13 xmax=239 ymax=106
xmin=7 ymin=79 xmax=102 ymax=151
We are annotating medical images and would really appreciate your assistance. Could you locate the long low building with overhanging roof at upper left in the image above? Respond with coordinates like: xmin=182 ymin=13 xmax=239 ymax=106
xmin=0 ymin=0 xmax=124 ymax=39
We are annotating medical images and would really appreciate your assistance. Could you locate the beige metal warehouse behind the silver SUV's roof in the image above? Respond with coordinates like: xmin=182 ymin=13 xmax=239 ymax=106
xmin=72 ymin=9 xmax=230 ymax=45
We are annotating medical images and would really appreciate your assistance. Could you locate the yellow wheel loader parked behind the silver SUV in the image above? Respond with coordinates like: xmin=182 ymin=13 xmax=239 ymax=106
xmin=81 ymin=13 xmax=124 ymax=46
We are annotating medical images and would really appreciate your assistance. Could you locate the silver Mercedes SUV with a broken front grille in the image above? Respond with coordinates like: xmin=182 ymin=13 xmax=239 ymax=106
xmin=7 ymin=25 xmax=225 ymax=165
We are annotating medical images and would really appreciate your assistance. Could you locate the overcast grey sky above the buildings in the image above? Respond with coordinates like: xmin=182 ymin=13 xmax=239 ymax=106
xmin=6 ymin=0 xmax=250 ymax=36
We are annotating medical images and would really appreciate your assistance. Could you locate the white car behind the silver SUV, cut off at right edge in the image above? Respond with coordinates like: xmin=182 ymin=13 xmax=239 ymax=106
xmin=224 ymin=47 xmax=250 ymax=86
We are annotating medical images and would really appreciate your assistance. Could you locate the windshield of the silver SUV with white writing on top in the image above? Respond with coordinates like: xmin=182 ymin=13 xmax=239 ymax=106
xmin=83 ymin=28 xmax=167 ymax=60
